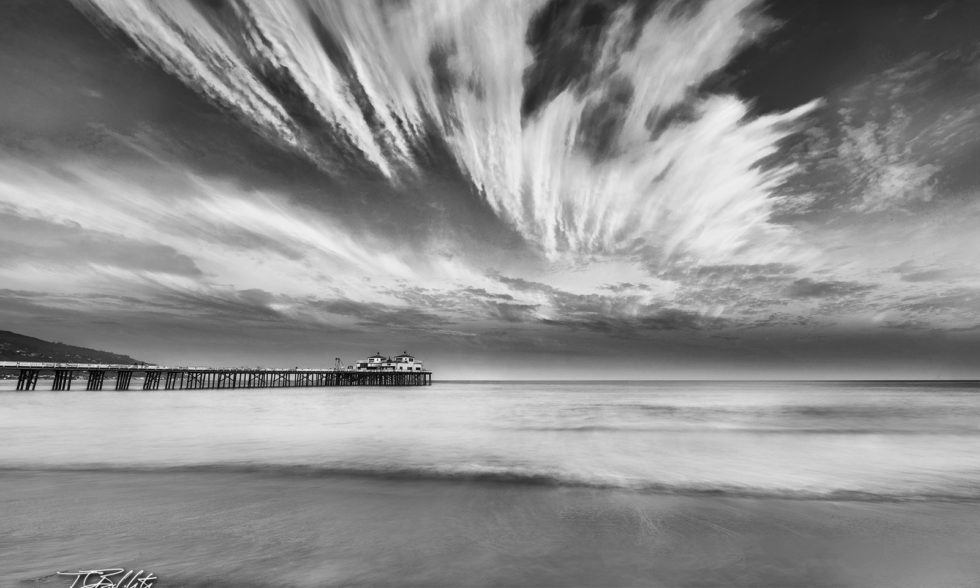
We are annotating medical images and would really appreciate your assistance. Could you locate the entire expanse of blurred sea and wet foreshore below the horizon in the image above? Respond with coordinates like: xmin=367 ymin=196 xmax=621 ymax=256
xmin=0 ymin=381 xmax=980 ymax=587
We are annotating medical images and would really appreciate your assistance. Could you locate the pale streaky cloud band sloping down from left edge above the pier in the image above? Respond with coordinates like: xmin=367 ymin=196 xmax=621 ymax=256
xmin=0 ymin=159 xmax=415 ymax=293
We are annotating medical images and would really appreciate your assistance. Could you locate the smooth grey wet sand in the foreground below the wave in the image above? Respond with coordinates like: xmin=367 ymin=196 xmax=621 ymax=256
xmin=0 ymin=470 xmax=980 ymax=587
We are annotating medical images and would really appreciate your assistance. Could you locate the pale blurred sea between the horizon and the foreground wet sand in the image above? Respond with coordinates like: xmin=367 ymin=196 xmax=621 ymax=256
xmin=0 ymin=382 xmax=980 ymax=499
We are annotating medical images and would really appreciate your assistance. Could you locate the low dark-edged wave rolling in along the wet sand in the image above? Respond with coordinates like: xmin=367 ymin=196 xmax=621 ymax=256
xmin=0 ymin=463 xmax=980 ymax=502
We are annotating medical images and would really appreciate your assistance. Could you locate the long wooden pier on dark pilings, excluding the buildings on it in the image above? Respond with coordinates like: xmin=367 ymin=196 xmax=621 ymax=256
xmin=0 ymin=361 xmax=432 ymax=390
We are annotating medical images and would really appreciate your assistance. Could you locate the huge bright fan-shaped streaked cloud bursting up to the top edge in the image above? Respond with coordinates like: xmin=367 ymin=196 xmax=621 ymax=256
xmin=79 ymin=0 xmax=814 ymax=272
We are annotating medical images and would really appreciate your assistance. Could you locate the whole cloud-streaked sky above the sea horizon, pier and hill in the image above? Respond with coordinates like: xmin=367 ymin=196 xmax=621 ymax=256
xmin=0 ymin=0 xmax=980 ymax=379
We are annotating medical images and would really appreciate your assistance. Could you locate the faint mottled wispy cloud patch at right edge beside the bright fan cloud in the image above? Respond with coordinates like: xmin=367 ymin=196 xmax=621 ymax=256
xmin=786 ymin=49 xmax=980 ymax=216
